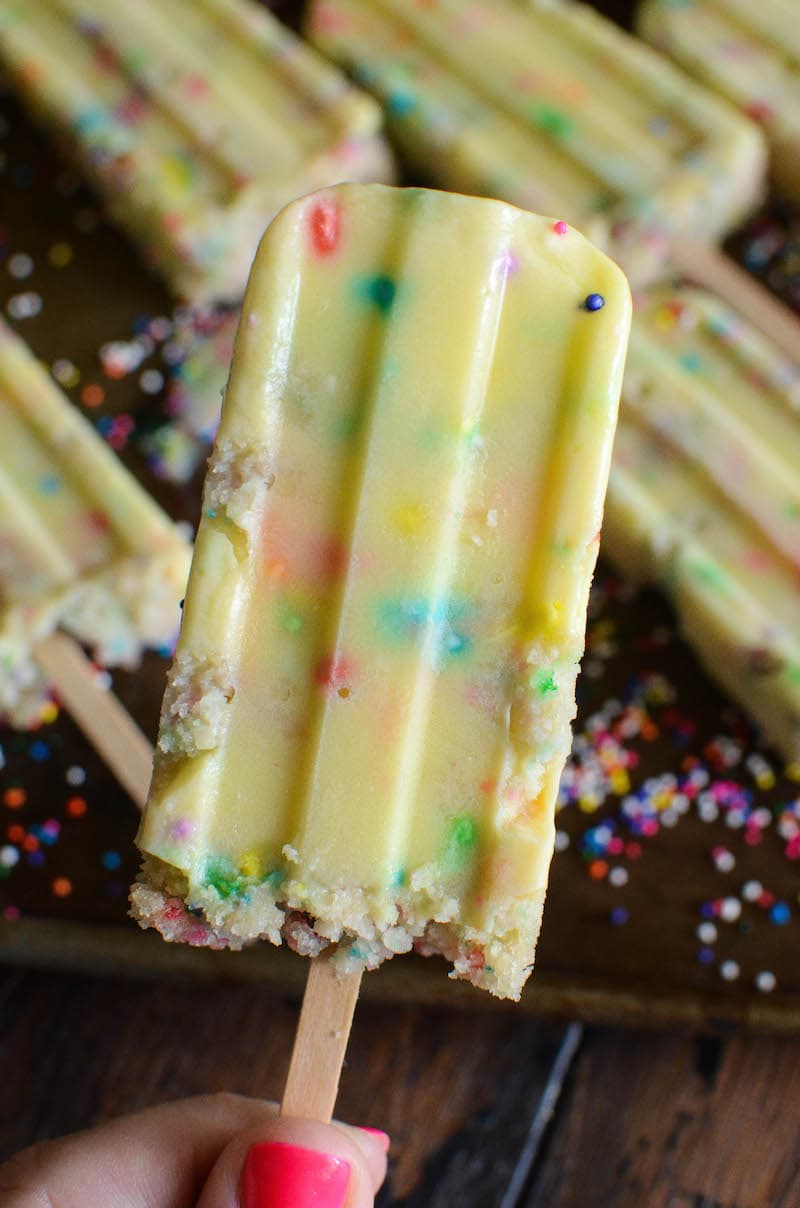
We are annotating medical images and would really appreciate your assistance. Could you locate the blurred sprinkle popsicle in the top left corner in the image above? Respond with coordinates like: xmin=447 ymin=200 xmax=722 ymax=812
xmin=0 ymin=0 xmax=393 ymax=301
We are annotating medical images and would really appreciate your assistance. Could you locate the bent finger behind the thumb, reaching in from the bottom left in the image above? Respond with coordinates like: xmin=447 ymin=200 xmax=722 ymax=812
xmin=0 ymin=1094 xmax=277 ymax=1208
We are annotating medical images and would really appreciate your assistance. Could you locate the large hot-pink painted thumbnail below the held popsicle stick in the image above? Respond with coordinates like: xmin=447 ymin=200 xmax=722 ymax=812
xmin=242 ymin=1142 xmax=350 ymax=1208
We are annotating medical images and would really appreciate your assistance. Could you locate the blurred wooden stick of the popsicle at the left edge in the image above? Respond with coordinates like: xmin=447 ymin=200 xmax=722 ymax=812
xmin=34 ymin=633 xmax=152 ymax=809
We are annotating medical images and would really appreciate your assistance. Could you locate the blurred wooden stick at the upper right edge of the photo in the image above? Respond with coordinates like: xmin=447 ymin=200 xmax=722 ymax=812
xmin=672 ymin=240 xmax=800 ymax=361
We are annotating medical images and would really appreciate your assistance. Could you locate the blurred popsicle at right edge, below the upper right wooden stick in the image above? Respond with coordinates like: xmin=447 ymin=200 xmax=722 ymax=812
xmin=603 ymin=289 xmax=800 ymax=760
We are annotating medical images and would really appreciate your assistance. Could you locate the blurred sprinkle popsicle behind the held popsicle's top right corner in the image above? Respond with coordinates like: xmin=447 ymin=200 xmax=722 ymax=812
xmin=307 ymin=0 xmax=766 ymax=283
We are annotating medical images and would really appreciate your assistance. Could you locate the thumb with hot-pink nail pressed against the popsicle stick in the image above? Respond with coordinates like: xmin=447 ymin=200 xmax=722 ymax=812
xmin=197 ymin=1117 xmax=389 ymax=1208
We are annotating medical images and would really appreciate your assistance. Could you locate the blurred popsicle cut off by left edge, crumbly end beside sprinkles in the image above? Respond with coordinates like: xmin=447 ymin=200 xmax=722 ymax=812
xmin=0 ymin=320 xmax=190 ymax=796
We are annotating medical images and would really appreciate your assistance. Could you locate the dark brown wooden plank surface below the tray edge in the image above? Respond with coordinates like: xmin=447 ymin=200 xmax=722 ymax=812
xmin=6 ymin=971 xmax=800 ymax=1208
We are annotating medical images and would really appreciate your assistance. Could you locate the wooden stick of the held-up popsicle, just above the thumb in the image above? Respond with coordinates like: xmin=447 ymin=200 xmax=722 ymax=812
xmin=280 ymin=956 xmax=361 ymax=1123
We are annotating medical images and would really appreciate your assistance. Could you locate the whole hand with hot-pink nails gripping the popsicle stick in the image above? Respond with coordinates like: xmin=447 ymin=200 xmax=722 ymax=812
xmin=0 ymin=1094 xmax=389 ymax=1208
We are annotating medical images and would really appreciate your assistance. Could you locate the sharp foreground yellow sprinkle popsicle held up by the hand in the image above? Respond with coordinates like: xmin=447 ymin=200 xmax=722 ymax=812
xmin=133 ymin=186 xmax=630 ymax=998
